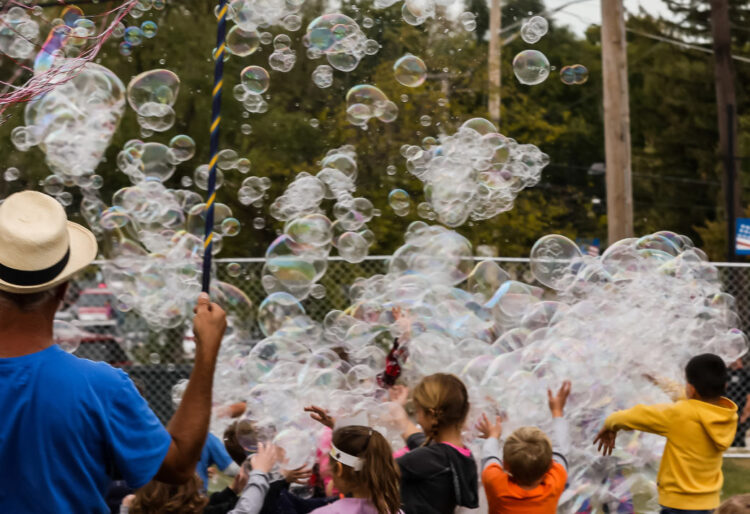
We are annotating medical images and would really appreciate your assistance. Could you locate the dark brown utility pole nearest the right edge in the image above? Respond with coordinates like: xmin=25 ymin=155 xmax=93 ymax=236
xmin=711 ymin=0 xmax=742 ymax=262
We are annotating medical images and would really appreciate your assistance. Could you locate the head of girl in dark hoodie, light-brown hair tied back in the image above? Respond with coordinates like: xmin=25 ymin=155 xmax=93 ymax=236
xmin=414 ymin=373 xmax=469 ymax=440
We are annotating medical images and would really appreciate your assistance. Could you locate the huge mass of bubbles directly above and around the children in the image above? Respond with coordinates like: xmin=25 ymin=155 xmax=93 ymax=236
xmin=209 ymin=226 xmax=747 ymax=512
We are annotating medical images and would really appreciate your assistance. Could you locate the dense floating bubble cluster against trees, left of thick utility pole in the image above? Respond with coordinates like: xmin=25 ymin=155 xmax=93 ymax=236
xmin=401 ymin=118 xmax=549 ymax=227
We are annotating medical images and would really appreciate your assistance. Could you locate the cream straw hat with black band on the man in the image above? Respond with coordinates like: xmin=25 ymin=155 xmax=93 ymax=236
xmin=0 ymin=191 xmax=97 ymax=294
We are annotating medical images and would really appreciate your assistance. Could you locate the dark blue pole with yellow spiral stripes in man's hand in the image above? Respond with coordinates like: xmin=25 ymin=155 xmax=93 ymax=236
xmin=203 ymin=0 xmax=227 ymax=292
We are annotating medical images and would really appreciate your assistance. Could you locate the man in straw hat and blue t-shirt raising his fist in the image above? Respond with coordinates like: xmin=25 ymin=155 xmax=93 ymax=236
xmin=0 ymin=191 xmax=226 ymax=514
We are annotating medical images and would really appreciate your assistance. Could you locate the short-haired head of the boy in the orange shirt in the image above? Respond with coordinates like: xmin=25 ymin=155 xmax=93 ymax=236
xmin=503 ymin=427 xmax=552 ymax=487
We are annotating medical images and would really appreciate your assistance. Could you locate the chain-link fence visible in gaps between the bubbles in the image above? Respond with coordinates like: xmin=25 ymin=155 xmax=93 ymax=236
xmin=60 ymin=257 xmax=750 ymax=446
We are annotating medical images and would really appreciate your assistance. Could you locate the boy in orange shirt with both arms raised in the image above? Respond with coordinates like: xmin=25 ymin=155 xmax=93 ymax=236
xmin=477 ymin=381 xmax=570 ymax=514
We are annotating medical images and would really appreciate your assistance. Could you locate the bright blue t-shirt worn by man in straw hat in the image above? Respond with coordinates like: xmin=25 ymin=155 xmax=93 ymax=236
xmin=0 ymin=346 xmax=172 ymax=513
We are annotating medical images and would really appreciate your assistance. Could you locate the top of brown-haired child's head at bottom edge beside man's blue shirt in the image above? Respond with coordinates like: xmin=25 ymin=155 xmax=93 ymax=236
xmin=129 ymin=474 xmax=208 ymax=514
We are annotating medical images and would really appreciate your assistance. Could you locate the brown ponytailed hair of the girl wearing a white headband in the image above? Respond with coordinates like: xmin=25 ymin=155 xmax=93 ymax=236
xmin=331 ymin=425 xmax=401 ymax=514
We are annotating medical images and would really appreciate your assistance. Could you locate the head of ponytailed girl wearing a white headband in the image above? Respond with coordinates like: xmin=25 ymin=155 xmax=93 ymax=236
xmin=330 ymin=425 xmax=401 ymax=514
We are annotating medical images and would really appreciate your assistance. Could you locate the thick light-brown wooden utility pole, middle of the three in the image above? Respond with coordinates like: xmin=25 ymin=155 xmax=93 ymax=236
xmin=601 ymin=0 xmax=633 ymax=244
